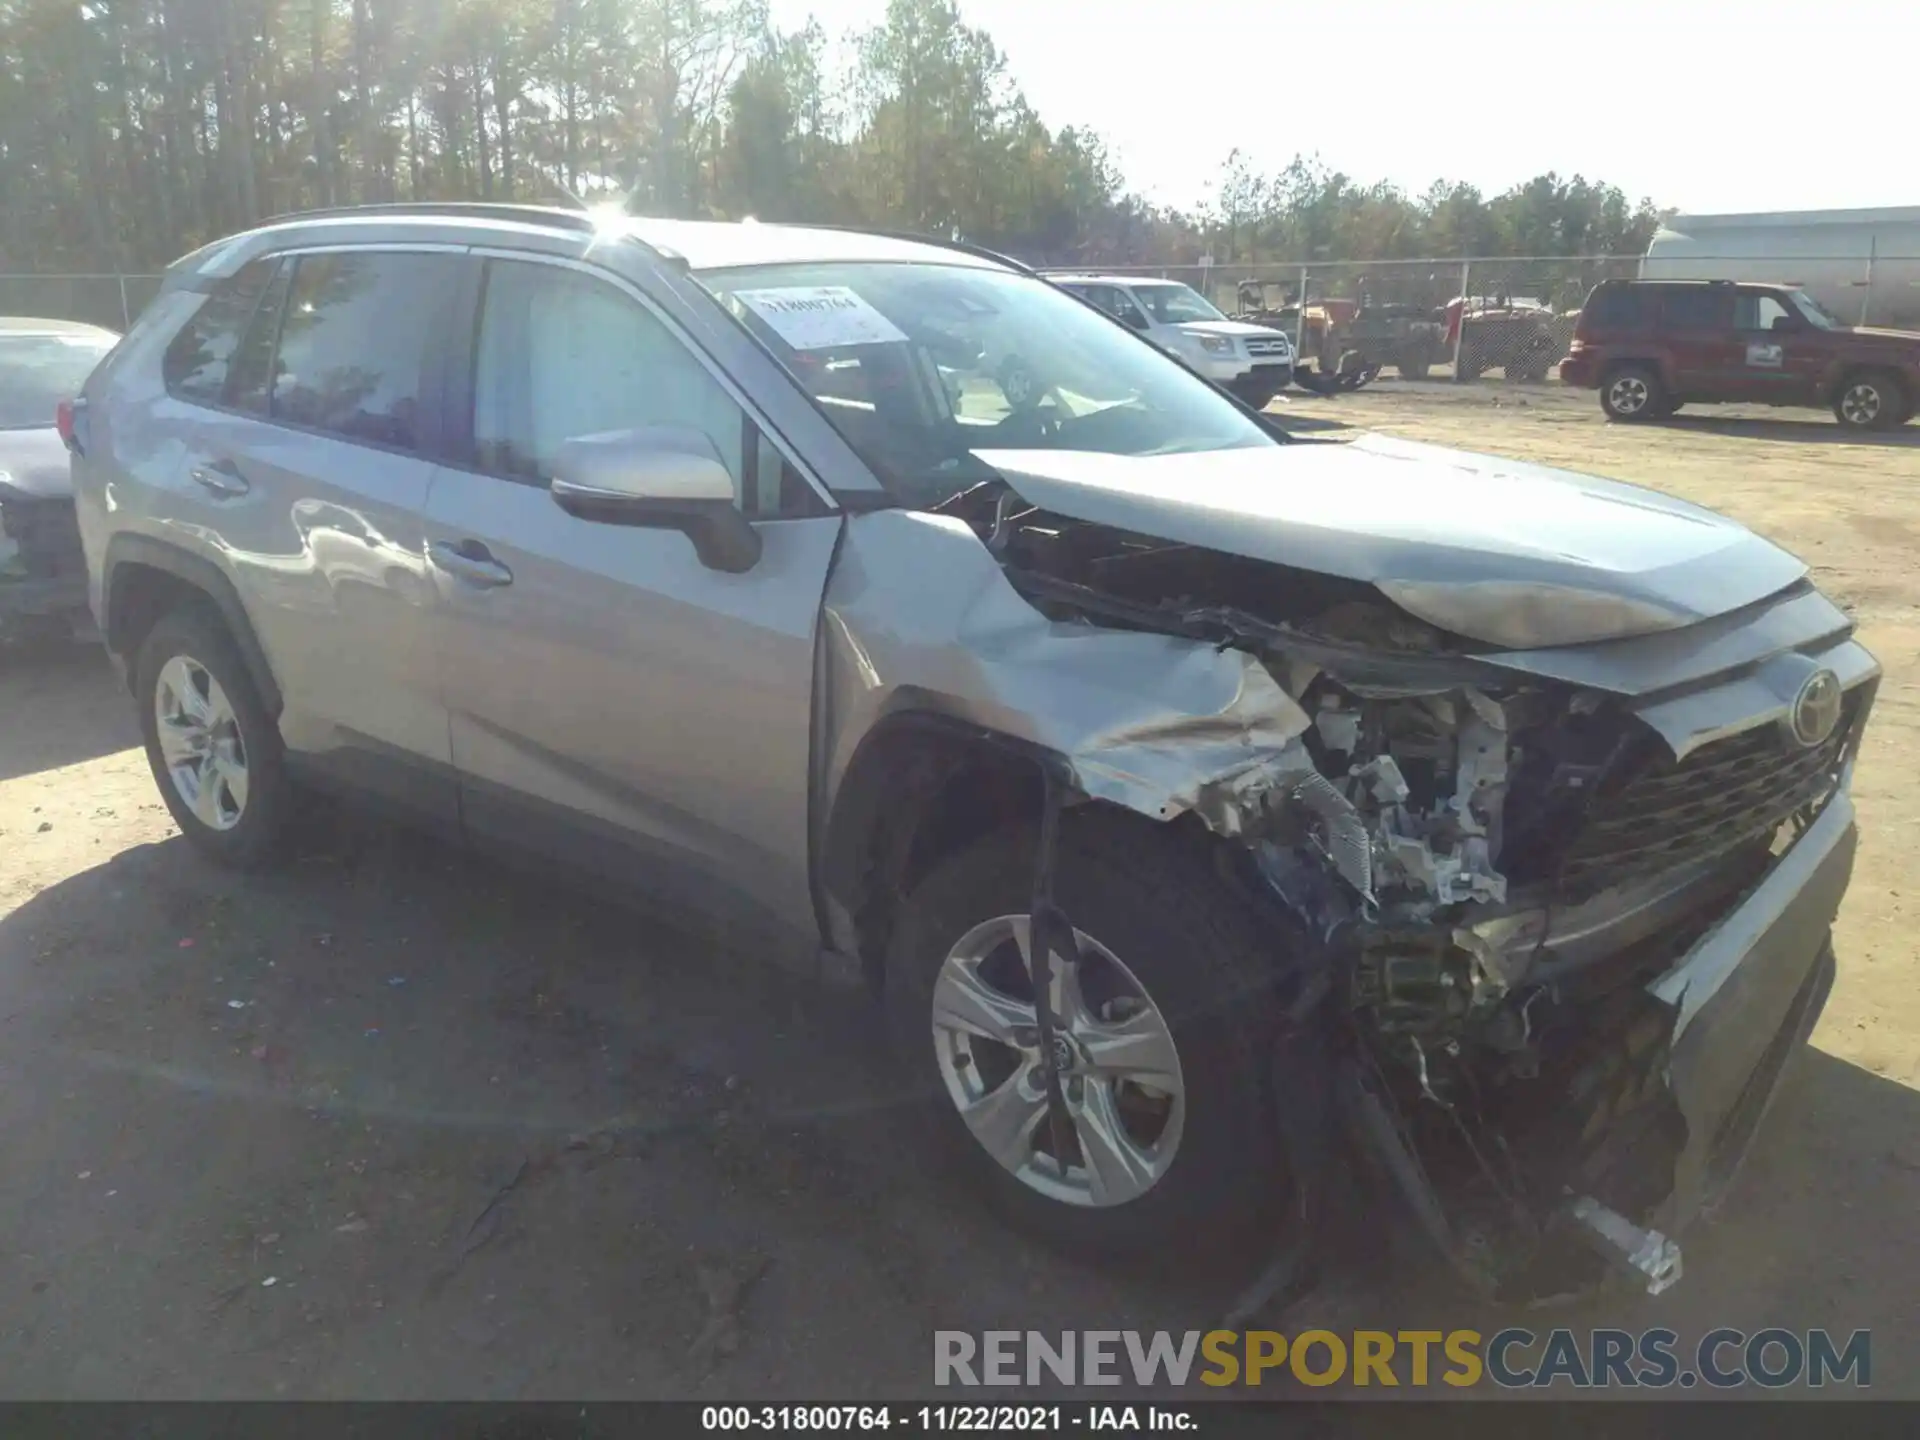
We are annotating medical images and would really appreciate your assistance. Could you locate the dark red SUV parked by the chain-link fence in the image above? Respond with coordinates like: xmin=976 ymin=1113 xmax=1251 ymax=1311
xmin=1561 ymin=280 xmax=1920 ymax=430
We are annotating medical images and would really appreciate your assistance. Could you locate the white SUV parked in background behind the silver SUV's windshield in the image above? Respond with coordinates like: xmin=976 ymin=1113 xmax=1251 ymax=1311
xmin=1046 ymin=275 xmax=1294 ymax=409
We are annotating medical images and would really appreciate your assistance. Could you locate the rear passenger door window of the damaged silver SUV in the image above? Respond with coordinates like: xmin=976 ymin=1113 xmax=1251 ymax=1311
xmin=271 ymin=252 xmax=453 ymax=449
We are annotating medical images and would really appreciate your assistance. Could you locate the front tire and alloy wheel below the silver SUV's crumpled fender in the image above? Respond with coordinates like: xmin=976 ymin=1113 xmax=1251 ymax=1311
xmin=885 ymin=812 xmax=1288 ymax=1263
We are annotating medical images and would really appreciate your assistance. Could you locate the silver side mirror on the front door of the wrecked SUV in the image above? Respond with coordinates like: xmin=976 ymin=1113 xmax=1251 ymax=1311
xmin=549 ymin=424 xmax=760 ymax=574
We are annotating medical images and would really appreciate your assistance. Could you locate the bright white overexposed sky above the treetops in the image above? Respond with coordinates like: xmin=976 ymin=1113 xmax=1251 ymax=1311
xmin=770 ymin=0 xmax=1920 ymax=213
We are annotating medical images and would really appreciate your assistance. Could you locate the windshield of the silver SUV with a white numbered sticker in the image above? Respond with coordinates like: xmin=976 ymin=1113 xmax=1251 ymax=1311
xmin=701 ymin=263 xmax=1275 ymax=507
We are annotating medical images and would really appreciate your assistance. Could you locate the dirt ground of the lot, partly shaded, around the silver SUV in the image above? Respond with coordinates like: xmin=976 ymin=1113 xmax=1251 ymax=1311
xmin=0 ymin=380 xmax=1920 ymax=1398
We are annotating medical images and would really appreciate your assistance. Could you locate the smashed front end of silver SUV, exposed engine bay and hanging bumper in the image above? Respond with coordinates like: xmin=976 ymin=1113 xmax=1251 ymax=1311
xmin=947 ymin=484 xmax=1872 ymax=1302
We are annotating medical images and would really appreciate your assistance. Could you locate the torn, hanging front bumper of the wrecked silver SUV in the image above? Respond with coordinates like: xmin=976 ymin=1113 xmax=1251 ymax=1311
xmin=1342 ymin=787 xmax=1857 ymax=1304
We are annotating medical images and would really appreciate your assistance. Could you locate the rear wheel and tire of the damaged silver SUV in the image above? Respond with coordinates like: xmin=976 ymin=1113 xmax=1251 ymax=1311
xmin=134 ymin=605 xmax=294 ymax=870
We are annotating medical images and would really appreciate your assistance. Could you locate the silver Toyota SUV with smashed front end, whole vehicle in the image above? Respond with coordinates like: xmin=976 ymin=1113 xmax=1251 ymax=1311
xmin=71 ymin=205 xmax=1878 ymax=1300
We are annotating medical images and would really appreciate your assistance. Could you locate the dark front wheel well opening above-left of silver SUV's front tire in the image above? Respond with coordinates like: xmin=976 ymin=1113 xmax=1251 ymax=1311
xmin=824 ymin=718 xmax=1043 ymax=989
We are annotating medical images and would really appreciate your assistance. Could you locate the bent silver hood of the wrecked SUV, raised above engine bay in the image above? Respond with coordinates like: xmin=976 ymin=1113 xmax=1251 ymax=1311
xmin=981 ymin=436 xmax=1807 ymax=649
